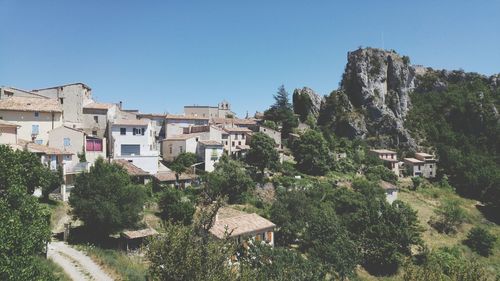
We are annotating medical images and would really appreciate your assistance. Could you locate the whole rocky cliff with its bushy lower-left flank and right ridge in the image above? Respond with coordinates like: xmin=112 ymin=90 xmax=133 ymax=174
xmin=307 ymin=48 xmax=500 ymax=148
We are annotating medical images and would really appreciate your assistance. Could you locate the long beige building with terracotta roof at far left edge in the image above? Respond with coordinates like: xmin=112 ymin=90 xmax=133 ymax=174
xmin=0 ymin=97 xmax=63 ymax=145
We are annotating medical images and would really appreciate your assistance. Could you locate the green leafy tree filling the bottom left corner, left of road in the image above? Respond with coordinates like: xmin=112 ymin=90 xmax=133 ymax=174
xmin=0 ymin=185 xmax=56 ymax=280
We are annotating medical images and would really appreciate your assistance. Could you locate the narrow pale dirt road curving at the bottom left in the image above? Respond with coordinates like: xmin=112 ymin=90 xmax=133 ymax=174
xmin=47 ymin=242 xmax=113 ymax=281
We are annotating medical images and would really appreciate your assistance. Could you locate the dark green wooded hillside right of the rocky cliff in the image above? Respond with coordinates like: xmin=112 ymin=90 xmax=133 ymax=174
xmin=405 ymin=71 xmax=500 ymax=214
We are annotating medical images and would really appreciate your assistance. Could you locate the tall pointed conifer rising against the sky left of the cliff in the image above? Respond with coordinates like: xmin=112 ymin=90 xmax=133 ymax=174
xmin=264 ymin=85 xmax=299 ymax=138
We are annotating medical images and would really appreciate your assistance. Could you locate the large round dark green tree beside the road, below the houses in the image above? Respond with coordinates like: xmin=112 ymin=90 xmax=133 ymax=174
xmin=69 ymin=158 xmax=146 ymax=236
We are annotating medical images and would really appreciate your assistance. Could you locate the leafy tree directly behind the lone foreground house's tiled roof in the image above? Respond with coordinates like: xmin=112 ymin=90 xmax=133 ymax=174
xmin=206 ymin=156 xmax=255 ymax=204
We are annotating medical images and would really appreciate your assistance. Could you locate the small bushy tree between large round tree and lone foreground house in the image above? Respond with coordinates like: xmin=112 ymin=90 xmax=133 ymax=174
xmin=158 ymin=188 xmax=195 ymax=225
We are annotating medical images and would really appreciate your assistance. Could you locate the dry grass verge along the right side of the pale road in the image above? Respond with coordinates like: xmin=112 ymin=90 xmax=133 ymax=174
xmin=78 ymin=245 xmax=148 ymax=281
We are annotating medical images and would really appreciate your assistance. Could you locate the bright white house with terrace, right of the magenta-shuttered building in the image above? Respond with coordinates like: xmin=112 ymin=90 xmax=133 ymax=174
xmin=110 ymin=119 xmax=158 ymax=175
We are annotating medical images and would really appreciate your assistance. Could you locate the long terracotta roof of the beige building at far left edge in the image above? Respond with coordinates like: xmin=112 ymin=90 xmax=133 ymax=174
xmin=0 ymin=97 xmax=62 ymax=112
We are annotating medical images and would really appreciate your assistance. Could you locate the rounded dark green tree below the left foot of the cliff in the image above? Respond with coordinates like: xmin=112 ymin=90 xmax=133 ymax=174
xmin=292 ymin=130 xmax=331 ymax=175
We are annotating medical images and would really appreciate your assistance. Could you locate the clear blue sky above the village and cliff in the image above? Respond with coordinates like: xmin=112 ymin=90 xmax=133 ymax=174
xmin=0 ymin=0 xmax=500 ymax=115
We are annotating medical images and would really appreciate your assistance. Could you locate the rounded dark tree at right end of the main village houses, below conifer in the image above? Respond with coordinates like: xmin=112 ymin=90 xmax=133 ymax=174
xmin=246 ymin=133 xmax=279 ymax=175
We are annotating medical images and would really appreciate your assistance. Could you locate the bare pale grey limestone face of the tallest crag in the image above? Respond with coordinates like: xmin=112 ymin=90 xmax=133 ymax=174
xmin=341 ymin=48 xmax=422 ymax=147
